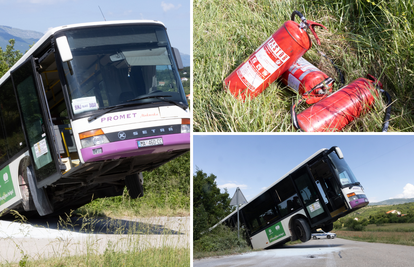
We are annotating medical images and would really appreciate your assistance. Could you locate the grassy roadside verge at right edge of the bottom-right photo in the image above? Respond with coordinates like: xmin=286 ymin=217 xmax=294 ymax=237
xmin=335 ymin=223 xmax=414 ymax=246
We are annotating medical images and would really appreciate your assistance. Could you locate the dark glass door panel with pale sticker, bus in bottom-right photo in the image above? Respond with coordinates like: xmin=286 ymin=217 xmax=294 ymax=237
xmin=291 ymin=165 xmax=331 ymax=225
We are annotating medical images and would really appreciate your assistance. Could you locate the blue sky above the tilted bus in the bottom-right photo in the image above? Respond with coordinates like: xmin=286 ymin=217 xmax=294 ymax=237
xmin=192 ymin=133 xmax=414 ymax=202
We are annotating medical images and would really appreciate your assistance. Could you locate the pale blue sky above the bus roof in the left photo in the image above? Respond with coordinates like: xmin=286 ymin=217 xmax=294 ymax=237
xmin=0 ymin=0 xmax=191 ymax=55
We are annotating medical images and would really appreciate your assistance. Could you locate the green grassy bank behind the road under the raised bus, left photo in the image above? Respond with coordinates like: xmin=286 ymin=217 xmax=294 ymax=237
xmin=75 ymin=152 xmax=190 ymax=217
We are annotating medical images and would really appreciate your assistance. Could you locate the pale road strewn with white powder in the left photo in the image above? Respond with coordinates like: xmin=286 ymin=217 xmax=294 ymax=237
xmin=0 ymin=217 xmax=190 ymax=263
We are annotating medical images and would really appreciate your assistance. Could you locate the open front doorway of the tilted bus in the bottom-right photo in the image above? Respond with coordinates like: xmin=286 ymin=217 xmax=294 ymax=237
xmin=310 ymin=158 xmax=347 ymax=217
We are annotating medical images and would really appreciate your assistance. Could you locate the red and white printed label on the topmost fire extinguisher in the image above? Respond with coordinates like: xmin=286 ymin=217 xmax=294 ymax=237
xmin=237 ymin=37 xmax=290 ymax=92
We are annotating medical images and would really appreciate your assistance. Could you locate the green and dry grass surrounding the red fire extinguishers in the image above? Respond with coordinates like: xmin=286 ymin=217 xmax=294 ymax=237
xmin=193 ymin=0 xmax=414 ymax=132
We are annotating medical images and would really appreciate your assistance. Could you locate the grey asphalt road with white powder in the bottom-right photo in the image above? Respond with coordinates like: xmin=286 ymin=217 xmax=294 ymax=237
xmin=194 ymin=238 xmax=414 ymax=267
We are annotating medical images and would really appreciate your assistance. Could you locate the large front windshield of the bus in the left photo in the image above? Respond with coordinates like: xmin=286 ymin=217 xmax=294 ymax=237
xmin=58 ymin=25 xmax=188 ymax=116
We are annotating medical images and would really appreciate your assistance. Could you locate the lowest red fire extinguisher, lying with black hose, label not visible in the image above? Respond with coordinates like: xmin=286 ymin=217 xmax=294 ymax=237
xmin=291 ymin=75 xmax=391 ymax=132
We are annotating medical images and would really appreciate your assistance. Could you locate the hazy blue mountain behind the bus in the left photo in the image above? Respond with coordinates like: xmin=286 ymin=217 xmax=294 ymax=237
xmin=0 ymin=25 xmax=191 ymax=67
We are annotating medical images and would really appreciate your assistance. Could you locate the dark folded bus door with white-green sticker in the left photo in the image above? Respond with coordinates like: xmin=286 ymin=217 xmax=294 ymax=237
xmin=11 ymin=56 xmax=61 ymax=188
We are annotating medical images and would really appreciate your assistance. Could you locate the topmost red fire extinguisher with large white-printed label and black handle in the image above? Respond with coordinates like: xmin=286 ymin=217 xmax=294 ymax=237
xmin=224 ymin=11 xmax=326 ymax=100
